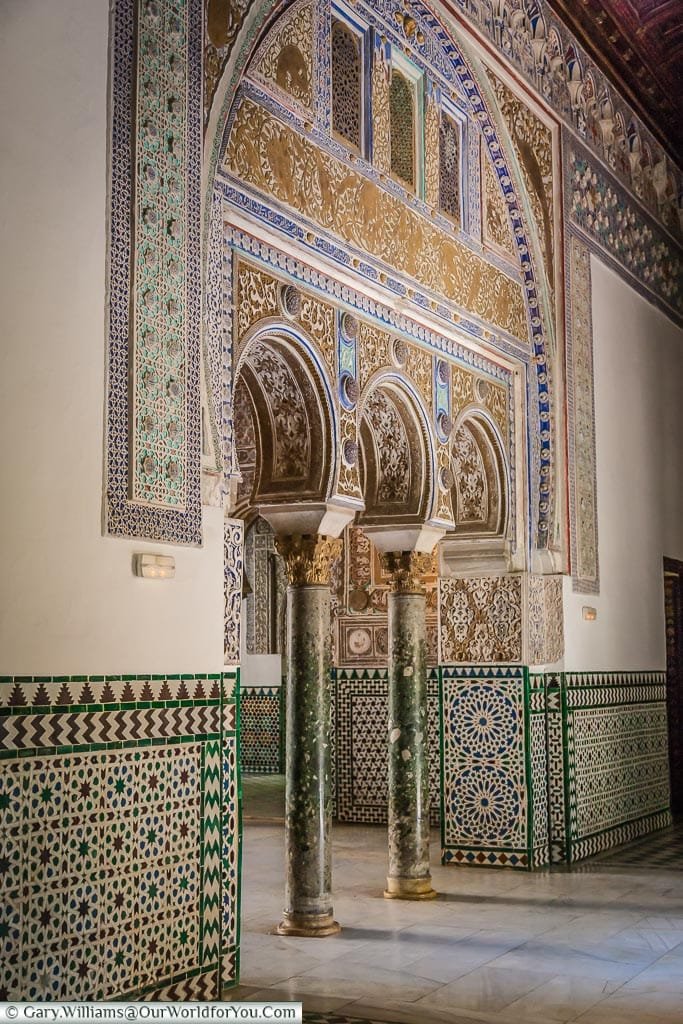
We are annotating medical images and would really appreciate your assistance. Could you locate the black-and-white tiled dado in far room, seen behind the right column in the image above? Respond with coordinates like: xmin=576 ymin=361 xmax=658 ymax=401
xmin=333 ymin=669 xmax=441 ymax=825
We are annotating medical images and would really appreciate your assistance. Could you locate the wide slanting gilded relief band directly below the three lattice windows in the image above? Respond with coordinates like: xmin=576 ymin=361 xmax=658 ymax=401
xmin=225 ymin=99 xmax=526 ymax=340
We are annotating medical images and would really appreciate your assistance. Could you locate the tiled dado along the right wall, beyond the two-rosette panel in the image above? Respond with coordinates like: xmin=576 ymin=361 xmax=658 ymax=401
xmin=562 ymin=672 xmax=671 ymax=861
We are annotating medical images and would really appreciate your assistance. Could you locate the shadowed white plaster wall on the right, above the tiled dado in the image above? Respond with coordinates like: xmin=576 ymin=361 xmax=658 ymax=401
xmin=564 ymin=258 xmax=683 ymax=671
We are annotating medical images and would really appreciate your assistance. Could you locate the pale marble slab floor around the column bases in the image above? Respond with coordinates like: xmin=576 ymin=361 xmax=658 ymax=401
xmin=225 ymin=776 xmax=683 ymax=1024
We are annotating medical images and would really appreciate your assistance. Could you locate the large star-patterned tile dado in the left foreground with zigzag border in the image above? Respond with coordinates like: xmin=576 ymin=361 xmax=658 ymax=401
xmin=0 ymin=675 xmax=239 ymax=999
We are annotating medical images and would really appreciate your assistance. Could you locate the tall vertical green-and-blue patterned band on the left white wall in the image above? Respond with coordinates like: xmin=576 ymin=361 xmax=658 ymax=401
xmin=106 ymin=0 xmax=202 ymax=544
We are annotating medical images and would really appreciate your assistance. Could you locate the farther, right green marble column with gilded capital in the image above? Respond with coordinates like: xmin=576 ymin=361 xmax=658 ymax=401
xmin=382 ymin=551 xmax=436 ymax=900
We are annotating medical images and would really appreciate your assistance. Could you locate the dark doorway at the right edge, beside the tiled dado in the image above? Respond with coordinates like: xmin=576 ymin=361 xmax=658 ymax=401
xmin=664 ymin=558 xmax=683 ymax=816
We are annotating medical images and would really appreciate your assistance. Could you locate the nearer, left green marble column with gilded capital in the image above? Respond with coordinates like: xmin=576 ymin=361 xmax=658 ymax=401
xmin=275 ymin=535 xmax=342 ymax=938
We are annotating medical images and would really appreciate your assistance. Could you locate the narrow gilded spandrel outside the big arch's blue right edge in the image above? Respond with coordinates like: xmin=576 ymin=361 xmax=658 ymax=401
xmin=486 ymin=69 xmax=554 ymax=288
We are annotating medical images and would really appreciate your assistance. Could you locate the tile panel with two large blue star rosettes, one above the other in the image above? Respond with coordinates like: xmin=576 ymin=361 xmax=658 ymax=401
xmin=440 ymin=666 xmax=548 ymax=869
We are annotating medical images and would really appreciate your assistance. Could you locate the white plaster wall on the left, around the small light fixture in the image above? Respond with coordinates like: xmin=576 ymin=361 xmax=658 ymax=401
xmin=0 ymin=0 xmax=223 ymax=675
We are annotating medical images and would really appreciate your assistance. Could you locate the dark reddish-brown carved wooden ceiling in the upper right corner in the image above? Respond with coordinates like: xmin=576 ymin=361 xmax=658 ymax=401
xmin=548 ymin=0 xmax=683 ymax=166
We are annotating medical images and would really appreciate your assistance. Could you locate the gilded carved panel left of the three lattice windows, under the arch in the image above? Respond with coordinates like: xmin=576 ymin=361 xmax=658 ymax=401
xmin=250 ymin=2 xmax=313 ymax=109
